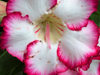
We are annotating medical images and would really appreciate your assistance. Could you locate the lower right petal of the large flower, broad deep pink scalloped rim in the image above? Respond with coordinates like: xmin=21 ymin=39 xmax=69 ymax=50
xmin=57 ymin=21 xmax=98 ymax=68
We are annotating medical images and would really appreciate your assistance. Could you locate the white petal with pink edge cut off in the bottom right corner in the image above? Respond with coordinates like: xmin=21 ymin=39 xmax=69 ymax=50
xmin=80 ymin=60 xmax=100 ymax=75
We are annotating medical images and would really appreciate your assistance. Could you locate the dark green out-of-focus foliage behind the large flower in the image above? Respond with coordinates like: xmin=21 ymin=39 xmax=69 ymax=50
xmin=0 ymin=0 xmax=100 ymax=75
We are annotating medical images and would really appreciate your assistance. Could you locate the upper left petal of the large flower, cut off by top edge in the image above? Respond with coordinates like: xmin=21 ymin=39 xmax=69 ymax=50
xmin=7 ymin=0 xmax=57 ymax=21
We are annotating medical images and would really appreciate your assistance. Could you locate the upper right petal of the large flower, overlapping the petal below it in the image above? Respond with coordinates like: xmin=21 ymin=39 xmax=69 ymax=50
xmin=54 ymin=0 xmax=98 ymax=30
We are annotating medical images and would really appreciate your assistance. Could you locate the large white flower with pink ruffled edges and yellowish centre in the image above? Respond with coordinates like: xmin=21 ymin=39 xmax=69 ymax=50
xmin=0 ymin=0 xmax=99 ymax=75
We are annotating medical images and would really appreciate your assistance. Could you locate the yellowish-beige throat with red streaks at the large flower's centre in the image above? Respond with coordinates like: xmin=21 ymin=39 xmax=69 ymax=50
xmin=35 ymin=13 xmax=65 ymax=43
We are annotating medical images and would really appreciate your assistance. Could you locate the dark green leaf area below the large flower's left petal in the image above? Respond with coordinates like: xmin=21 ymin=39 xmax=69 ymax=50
xmin=0 ymin=51 xmax=24 ymax=75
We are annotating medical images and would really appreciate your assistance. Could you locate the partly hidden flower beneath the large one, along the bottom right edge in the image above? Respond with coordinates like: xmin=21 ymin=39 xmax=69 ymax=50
xmin=58 ymin=56 xmax=100 ymax=75
